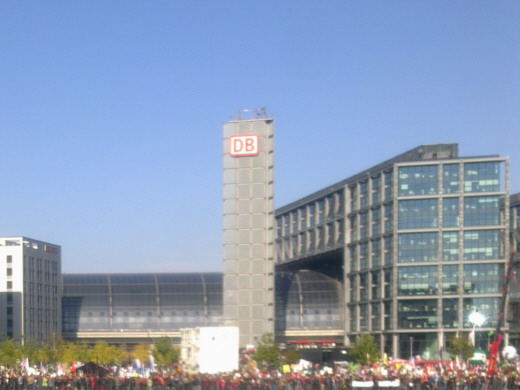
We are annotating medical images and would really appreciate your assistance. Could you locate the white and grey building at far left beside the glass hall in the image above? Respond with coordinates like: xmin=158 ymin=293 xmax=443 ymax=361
xmin=0 ymin=237 xmax=62 ymax=343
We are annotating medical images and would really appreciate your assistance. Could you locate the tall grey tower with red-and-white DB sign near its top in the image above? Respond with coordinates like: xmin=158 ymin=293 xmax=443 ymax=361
xmin=223 ymin=109 xmax=274 ymax=347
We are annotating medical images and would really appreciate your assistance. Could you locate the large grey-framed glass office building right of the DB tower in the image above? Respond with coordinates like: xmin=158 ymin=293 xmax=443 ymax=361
xmin=276 ymin=144 xmax=509 ymax=358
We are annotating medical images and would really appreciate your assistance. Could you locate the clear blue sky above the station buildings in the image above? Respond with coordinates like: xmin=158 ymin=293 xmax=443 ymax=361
xmin=0 ymin=0 xmax=520 ymax=272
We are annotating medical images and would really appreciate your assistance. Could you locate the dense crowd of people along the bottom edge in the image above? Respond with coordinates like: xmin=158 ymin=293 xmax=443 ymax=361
xmin=0 ymin=363 xmax=520 ymax=390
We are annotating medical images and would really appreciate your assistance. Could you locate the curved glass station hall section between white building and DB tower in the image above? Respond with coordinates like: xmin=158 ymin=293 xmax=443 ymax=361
xmin=62 ymin=273 xmax=222 ymax=332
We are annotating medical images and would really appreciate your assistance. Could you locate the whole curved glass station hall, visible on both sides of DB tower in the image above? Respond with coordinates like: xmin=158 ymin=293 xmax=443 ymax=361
xmin=62 ymin=270 xmax=343 ymax=332
